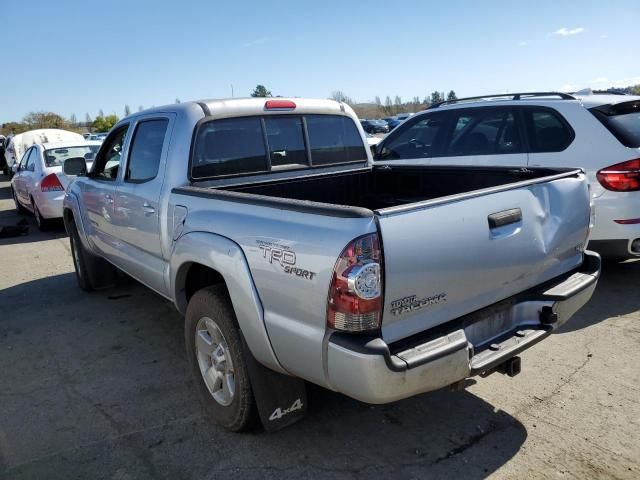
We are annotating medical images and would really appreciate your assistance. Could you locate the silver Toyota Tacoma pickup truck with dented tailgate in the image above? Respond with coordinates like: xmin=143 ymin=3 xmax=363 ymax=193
xmin=64 ymin=98 xmax=600 ymax=431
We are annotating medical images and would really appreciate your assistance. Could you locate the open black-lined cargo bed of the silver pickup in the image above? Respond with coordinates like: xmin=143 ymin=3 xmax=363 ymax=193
xmin=219 ymin=166 xmax=569 ymax=210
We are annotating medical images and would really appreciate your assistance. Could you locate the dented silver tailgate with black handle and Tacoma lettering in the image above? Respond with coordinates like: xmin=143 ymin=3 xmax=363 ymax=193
xmin=376 ymin=172 xmax=590 ymax=342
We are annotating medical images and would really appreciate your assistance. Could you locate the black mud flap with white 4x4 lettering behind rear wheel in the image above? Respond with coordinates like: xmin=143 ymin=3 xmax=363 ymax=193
xmin=242 ymin=337 xmax=307 ymax=432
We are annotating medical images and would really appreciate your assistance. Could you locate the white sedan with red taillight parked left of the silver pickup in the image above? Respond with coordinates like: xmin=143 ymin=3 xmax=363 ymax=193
xmin=11 ymin=141 xmax=102 ymax=230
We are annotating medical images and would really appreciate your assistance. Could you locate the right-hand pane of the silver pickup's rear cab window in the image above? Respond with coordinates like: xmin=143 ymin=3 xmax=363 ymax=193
xmin=305 ymin=115 xmax=367 ymax=166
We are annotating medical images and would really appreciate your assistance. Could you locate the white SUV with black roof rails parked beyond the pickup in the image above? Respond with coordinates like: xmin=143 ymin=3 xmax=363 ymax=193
xmin=376 ymin=92 xmax=640 ymax=259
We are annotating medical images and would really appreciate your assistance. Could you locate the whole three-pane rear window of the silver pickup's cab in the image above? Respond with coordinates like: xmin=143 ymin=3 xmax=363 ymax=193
xmin=191 ymin=115 xmax=367 ymax=179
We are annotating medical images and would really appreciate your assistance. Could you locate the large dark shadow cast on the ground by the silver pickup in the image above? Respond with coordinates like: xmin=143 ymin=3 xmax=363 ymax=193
xmin=0 ymin=273 xmax=527 ymax=479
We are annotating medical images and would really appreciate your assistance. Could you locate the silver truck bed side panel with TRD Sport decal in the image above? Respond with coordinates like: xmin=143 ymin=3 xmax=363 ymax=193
xmin=171 ymin=194 xmax=376 ymax=384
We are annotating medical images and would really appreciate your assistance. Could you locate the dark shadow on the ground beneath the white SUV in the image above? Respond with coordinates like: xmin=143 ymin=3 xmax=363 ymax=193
xmin=557 ymin=261 xmax=640 ymax=333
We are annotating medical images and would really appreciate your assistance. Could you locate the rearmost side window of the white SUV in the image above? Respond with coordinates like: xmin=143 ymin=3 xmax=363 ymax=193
xmin=523 ymin=107 xmax=574 ymax=153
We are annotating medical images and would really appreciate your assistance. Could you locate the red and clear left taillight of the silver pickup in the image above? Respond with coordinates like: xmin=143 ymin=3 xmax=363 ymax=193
xmin=327 ymin=233 xmax=383 ymax=332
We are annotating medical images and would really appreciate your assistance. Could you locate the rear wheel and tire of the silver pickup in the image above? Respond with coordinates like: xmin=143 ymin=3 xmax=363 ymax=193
xmin=185 ymin=285 xmax=257 ymax=432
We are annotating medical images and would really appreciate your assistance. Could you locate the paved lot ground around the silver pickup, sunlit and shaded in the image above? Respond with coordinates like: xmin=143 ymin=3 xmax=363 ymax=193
xmin=0 ymin=177 xmax=640 ymax=480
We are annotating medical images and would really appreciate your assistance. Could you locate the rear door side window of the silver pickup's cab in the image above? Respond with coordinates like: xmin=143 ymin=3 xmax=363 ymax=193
xmin=125 ymin=118 xmax=169 ymax=183
